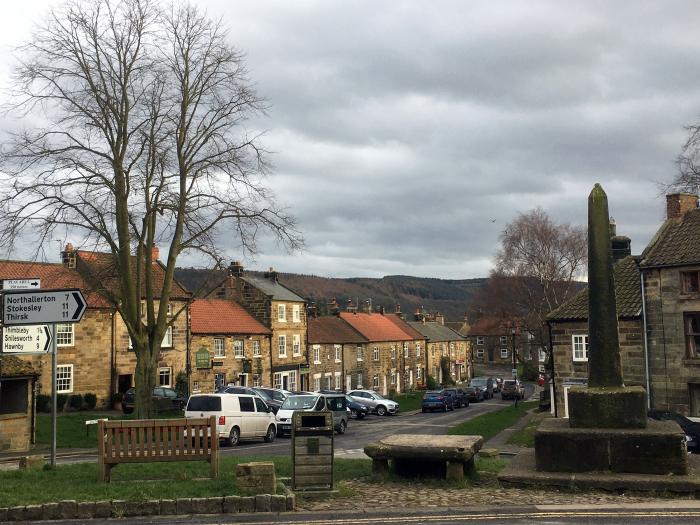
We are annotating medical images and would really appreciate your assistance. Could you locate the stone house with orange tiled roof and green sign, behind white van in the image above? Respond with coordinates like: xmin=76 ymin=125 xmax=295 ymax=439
xmin=190 ymin=299 xmax=273 ymax=393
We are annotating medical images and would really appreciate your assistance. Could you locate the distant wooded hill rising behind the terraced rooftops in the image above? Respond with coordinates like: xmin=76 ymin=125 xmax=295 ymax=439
xmin=175 ymin=268 xmax=488 ymax=321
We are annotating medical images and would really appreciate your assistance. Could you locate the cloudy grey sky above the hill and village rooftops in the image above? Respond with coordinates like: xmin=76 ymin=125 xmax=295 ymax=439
xmin=0 ymin=0 xmax=700 ymax=279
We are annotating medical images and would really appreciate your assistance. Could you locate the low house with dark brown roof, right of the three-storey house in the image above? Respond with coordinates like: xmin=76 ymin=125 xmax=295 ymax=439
xmin=308 ymin=316 xmax=369 ymax=391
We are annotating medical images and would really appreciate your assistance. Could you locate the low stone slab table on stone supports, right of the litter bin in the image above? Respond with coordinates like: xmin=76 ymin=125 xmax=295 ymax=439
xmin=365 ymin=434 xmax=484 ymax=480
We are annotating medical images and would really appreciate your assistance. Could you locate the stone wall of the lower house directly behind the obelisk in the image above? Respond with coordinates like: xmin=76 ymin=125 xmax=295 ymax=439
xmin=552 ymin=319 xmax=645 ymax=417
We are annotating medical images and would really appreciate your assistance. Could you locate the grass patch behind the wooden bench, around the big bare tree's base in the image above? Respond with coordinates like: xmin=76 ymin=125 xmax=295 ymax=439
xmin=36 ymin=412 xmax=183 ymax=448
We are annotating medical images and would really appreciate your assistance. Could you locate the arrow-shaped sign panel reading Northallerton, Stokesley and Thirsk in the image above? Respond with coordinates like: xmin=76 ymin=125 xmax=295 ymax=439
xmin=2 ymin=288 xmax=87 ymax=325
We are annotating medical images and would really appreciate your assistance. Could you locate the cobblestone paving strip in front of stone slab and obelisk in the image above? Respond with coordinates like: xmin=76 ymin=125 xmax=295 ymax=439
xmin=297 ymin=480 xmax=693 ymax=511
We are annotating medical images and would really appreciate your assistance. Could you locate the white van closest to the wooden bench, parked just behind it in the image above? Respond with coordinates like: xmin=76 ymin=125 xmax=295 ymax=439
xmin=185 ymin=394 xmax=277 ymax=447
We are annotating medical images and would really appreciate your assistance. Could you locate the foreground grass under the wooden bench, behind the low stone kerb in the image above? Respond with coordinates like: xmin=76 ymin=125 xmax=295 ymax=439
xmin=0 ymin=456 xmax=372 ymax=507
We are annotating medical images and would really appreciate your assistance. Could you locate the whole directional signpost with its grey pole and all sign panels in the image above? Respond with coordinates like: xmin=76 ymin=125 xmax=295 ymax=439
xmin=2 ymin=286 xmax=87 ymax=467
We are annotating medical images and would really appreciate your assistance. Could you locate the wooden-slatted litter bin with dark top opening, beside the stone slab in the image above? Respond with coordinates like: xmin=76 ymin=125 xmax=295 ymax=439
xmin=292 ymin=410 xmax=333 ymax=490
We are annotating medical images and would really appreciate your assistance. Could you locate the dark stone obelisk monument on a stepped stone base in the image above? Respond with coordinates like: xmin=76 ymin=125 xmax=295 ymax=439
xmin=499 ymin=184 xmax=700 ymax=492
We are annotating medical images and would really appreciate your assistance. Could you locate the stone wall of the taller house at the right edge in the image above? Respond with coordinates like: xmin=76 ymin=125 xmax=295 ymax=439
xmin=644 ymin=266 xmax=700 ymax=416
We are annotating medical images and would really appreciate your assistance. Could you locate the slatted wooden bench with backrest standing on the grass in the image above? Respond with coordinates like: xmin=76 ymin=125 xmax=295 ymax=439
xmin=97 ymin=416 xmax=219 ymax=481
